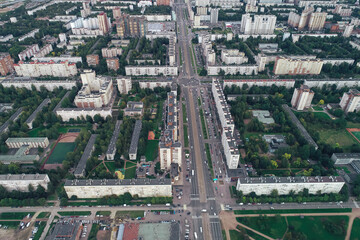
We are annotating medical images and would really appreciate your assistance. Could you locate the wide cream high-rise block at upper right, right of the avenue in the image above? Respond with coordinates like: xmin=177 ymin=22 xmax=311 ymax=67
xmin=274 ymin=57 xmax=324 ymax=75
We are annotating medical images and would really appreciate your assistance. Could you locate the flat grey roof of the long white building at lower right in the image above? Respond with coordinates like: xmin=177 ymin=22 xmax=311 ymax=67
xmin=239 ymin=176 xmax=344 ymax=184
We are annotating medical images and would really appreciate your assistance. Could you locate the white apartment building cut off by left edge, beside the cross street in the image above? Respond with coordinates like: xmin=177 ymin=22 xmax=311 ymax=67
xmin=0 ymin=173 xmax=50 ymax=192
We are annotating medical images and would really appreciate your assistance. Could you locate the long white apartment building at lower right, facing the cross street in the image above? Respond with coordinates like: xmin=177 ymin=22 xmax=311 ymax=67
xmin=236 ymin=176 xmax=345 ymax=196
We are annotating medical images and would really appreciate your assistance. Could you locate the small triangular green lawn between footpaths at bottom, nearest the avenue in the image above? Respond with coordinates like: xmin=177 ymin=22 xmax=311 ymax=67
xmin=236 ymin=216 xmax=287 ymax=239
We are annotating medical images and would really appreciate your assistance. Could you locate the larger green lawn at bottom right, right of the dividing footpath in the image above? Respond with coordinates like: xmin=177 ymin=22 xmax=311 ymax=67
xmin=287 ymin=216 xmax=349 ymax=240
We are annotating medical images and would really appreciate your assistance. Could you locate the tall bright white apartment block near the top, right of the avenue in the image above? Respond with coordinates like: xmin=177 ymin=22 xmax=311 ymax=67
xmin=240 ymin=13 xmax=276 ymax=35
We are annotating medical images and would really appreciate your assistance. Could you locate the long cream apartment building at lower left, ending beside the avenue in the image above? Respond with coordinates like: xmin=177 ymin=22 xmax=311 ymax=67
xmin=64 ymin=178 xmax=172 ymax=198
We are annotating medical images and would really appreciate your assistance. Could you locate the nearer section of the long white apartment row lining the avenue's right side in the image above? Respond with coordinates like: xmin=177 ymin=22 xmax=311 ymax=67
xmin=221 ymin=128 xmax=240 ymax=169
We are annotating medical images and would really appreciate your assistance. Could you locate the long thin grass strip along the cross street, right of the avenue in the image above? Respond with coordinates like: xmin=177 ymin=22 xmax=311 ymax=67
xmin=234 ymin=208 xmax=352 ymax=214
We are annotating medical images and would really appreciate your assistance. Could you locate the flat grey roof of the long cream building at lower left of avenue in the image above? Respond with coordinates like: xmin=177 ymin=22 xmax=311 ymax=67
xmin=65 ymin=178 xmax=171 ymax=186
